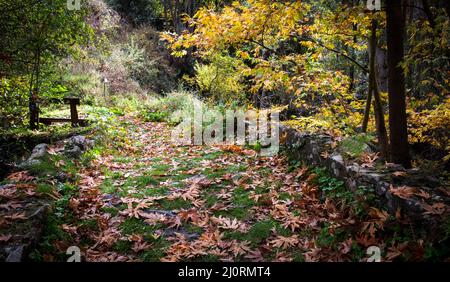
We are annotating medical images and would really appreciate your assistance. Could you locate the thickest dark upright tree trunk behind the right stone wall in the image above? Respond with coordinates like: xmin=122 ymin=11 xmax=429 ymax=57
xmin=386 ymin=0 xmax=411 ymax=168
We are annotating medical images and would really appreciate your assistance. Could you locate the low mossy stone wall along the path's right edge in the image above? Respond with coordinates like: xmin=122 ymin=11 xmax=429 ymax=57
xmin=280 ymin=125 xmax=449 ymax=217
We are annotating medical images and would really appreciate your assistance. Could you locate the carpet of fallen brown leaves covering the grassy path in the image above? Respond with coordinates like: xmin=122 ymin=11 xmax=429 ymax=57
xmin=0 ymin=117 xmax=448 ymax=262
